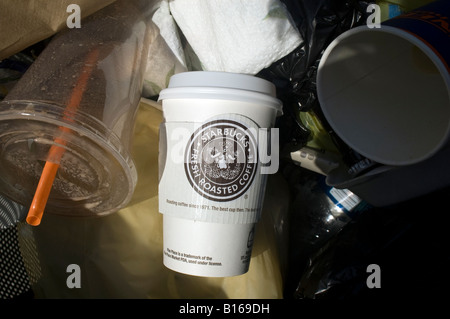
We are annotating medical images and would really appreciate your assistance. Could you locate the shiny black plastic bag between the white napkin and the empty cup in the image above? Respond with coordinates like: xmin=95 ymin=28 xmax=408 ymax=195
xmin=258 ymin=0 xmax=373 ymax=151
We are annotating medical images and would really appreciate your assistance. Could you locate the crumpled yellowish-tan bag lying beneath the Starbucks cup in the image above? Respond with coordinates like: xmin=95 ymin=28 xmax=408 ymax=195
xmin=19 ymin=103 xmax=288 ymax=299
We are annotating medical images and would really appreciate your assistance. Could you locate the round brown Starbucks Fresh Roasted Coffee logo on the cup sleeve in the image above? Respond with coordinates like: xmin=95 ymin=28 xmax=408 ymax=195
xmin=185 ymin=120 xmax=257 ymax=201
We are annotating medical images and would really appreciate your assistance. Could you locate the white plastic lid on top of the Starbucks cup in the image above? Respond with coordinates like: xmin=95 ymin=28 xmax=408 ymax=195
xmin=159 ymin=71 xmax=282 ymax=115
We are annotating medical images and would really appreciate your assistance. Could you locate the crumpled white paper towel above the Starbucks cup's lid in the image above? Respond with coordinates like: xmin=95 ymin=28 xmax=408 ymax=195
xmin=169 ymin=0 xmax=302 ymax=74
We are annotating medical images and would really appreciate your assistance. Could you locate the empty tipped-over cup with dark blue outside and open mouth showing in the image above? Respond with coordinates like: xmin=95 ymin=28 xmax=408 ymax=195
xmin=317 ymin=1 xmax=450 ymax=165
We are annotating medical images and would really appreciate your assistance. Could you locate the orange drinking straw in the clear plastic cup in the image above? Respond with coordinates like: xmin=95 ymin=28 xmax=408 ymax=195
xmin=27 ymin=49 xmax=99 ymax=226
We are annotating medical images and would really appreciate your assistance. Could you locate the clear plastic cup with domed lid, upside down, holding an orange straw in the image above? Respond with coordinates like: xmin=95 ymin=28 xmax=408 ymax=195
xmin=0 ymin=1 xmax=152 ymax=216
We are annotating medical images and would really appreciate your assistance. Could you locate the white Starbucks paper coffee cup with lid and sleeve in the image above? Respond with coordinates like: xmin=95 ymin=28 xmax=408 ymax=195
xmin=159 ymin=71 xmax=282 ymax=277
